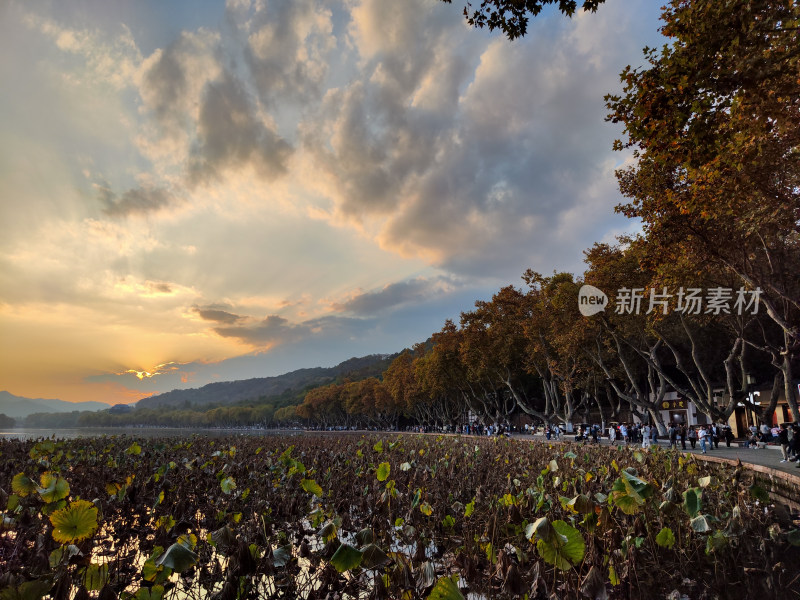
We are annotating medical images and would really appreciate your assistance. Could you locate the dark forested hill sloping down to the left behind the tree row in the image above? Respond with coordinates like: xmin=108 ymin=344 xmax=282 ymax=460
xmin=136 ymin=354 xmax=395 ymax=409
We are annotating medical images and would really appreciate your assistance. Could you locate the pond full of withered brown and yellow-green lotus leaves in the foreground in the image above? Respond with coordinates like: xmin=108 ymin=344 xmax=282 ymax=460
xmin=0 ymin=435 xmax=800 ymax=600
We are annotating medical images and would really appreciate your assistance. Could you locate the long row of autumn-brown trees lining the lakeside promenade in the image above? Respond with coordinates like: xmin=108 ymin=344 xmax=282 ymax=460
xmin=296 ymin=0 xmax=800 ymax=426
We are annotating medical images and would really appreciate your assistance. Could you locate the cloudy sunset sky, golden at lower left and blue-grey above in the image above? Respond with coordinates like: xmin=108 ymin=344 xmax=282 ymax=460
xmin=0 ymin=0 xmax=663 ymax=404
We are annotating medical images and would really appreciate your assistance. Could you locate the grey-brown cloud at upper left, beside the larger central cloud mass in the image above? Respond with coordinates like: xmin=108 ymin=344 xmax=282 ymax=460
xmin=139 ymin=29 xmax=292 ymax=188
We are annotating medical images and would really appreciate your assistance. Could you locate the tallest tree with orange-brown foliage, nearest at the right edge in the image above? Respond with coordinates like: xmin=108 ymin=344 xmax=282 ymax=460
xmin=606 ymin=0 xmax=800 ymax=420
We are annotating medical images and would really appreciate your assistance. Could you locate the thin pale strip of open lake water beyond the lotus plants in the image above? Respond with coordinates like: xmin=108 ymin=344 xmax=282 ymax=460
xmin=0 ymin=427 xmax=303 ymax=440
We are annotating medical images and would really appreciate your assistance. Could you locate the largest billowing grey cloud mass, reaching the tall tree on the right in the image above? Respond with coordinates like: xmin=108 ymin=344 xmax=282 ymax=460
xmin=302 ymin=0 xmax=650 ymax=277
